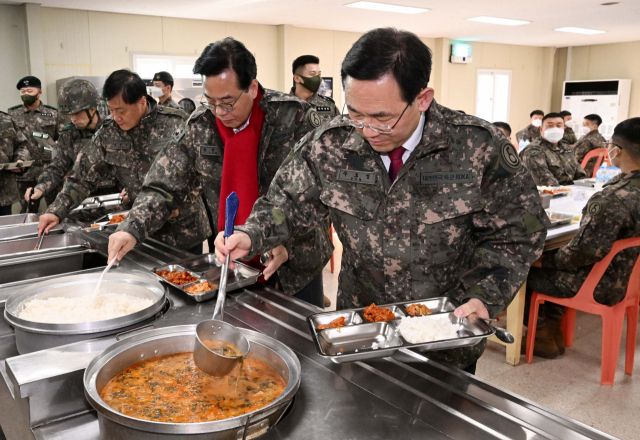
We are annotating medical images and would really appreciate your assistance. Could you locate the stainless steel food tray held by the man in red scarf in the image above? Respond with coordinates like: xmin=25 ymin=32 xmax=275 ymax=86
xmin=153 ymin=254 xmax=262 ymax=302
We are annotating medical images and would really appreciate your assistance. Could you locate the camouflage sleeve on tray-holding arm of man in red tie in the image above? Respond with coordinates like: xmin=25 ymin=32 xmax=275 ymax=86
xmin=460 ymin=142 xmax=548 ymax=317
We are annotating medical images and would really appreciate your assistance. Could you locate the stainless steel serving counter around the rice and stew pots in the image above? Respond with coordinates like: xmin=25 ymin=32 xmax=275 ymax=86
xmin=0 ymin=225 xmax=613 ymax=440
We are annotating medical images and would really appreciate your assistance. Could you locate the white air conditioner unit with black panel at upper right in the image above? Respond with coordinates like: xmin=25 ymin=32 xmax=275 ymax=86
xmin=562 ymin=79 xmax=631 ymax=139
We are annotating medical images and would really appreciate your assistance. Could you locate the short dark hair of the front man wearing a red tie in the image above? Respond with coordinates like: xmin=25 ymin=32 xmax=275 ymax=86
xmin=340 ymin=28 xmax=432 ymax=103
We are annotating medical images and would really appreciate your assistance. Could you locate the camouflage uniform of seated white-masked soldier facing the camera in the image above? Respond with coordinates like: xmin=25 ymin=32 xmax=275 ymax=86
xmin=520 ymin=138 xmax=586 ymax=186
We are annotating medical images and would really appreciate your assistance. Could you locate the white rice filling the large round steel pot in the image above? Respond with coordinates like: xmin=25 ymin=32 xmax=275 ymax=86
xmin=17 ymin=293 xmax=153 ymax=324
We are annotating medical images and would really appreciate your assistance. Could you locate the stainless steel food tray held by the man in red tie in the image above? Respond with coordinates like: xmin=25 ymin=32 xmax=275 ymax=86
xmin=307 ymin=297 xmax=494 ymax=364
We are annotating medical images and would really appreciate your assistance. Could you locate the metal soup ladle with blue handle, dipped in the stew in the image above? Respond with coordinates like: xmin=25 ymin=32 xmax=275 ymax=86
xmin=193 ymin=192 xmax=249 ymax=377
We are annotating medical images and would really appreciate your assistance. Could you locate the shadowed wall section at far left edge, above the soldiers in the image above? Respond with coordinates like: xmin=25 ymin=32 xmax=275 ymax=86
xmin=0 ymin=4 xmax=28 ymax=111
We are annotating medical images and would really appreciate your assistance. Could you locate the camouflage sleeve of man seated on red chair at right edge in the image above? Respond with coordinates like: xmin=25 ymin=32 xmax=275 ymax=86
xmin=542 ymin=197 xmax=633 ymax=269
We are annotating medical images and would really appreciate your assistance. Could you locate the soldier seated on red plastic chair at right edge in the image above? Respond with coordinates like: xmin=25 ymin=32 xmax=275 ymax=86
xmin=524 ymin=118 xmax=640 ymax=359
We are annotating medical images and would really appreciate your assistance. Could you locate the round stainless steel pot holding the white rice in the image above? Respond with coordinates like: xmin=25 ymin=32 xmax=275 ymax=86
xmin=4 ymin=272 xmax=166 ymax=354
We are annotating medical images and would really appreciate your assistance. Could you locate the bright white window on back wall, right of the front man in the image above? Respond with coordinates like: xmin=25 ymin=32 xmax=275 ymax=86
xmin=476 ymin=69 xmax=511 ymax=122
